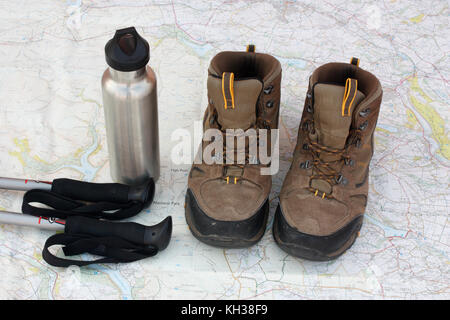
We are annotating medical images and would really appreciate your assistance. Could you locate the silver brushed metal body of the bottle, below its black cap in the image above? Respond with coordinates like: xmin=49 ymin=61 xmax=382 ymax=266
xmin=102 ymin=66 xmax=160 ymax=185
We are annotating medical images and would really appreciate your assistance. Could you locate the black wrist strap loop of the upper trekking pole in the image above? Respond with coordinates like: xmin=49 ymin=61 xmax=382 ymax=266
xmin=22 ymin=189 xmax=144 ymax=220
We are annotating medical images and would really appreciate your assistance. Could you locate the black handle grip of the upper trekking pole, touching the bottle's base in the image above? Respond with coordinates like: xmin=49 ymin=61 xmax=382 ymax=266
xmin=51 ymin=178 xmax=155 ymax=208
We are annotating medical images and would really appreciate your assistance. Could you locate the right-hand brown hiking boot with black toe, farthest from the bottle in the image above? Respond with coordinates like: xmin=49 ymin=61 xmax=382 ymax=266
xmin=273 ymin=58 xmax=382 ymax=261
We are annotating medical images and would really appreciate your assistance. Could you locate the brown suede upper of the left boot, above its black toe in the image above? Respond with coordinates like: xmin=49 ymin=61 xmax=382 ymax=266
xmin=188 ymin=51 xmax=281 ymax=221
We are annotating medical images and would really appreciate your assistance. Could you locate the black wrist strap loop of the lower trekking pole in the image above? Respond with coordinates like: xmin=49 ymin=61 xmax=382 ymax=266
xmin=42 ymin=233 xmax=158 ymax=267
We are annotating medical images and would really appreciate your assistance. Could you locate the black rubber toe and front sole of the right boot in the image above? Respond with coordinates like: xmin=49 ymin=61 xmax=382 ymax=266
xmin=273 ymin=205 xmax=363 ymax=261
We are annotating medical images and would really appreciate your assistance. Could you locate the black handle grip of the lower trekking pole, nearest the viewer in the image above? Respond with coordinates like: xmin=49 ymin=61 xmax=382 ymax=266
xmin=64 ymin=216 xmax=172 ymax=251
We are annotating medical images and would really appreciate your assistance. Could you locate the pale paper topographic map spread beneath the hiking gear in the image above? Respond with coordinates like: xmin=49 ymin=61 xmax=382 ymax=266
xmin=0 ymin=0 xmax=450 ymax=299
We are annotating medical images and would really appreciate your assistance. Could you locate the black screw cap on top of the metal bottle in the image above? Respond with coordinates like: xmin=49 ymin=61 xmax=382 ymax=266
xmin=105 ymin=27 xmax=150 ymax=71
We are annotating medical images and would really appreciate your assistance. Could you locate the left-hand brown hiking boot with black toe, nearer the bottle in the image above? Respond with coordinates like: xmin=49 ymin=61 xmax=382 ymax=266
xmin=186 ymin=46 xmax=281 ymax=248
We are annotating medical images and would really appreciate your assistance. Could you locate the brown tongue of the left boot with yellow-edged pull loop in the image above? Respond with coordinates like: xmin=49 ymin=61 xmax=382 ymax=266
xmin=208 ymin=73 xmax=262 ymax=131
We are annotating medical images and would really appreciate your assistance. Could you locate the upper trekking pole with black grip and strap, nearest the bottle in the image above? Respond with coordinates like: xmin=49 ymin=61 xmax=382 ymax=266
xmin=0 ymin=177 xmax=155 ymax=220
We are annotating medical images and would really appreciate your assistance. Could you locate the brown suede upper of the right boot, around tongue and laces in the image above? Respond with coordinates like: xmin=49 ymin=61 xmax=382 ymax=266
xmin=280 ymin=63 xmax=382 ymax=236
